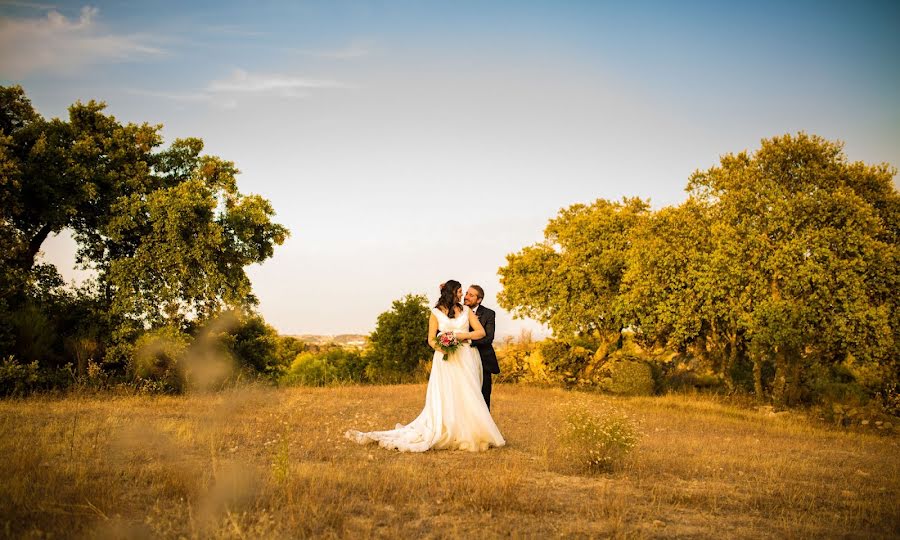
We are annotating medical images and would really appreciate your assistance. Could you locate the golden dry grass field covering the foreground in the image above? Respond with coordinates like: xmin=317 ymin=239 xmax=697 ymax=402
xmin=0 ymin=385 xmax=900 ymax=538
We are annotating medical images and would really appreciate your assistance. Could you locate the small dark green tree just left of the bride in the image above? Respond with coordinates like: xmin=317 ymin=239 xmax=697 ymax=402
xmin=366 ymin=294 xmax=434 ymax=380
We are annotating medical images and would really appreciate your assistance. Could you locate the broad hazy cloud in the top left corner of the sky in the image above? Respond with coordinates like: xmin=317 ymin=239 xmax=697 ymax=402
xmin=0 ymin=4 xmax=164 ymax=79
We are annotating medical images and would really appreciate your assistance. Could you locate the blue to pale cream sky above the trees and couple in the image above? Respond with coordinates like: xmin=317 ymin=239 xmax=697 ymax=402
xmin=0 ymin=0 xmax=900 ymax=337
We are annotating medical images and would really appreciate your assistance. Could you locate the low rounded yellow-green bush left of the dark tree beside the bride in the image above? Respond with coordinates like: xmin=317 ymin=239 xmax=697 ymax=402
xmin=280 ymin=348 xmax=366 ymax=386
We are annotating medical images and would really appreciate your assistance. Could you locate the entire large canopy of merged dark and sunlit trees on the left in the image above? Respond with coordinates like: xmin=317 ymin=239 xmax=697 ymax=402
xmin=0 ymin=86 xmax=288 ymax=368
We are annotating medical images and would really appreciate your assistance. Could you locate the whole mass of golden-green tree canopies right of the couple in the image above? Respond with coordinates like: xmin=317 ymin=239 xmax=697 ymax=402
xmin=498 ymin=133 xmax=900 ymax=403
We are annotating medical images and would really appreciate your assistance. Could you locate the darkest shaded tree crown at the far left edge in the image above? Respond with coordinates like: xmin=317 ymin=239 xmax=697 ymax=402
xmin=0 ymin=90 xmax=162 ymax=270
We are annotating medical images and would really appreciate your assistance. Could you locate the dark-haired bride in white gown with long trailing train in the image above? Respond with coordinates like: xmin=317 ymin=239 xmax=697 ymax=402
xmin=344 ymin=280 xmax=506 ymax=452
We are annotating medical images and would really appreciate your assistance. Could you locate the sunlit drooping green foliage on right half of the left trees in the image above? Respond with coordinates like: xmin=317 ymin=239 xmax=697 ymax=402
xmin=103 ymin=153 xmax=287 ymax=325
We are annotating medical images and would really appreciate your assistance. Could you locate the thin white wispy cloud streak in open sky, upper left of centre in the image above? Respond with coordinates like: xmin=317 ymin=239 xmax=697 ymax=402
xmin=131 ymin=69 xmax=351 ymax=108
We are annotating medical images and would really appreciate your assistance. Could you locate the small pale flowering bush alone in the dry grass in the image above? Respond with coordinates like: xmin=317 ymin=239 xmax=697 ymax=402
xmin=554 ymin=405 xmax=639 ymax=472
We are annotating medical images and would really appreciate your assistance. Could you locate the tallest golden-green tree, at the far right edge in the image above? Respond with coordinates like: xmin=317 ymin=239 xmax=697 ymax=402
xmin=689 ymin=133 xmax=900 ymax=404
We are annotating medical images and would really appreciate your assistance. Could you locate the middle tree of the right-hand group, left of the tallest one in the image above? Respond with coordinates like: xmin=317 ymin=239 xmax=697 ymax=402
xmin=621 ymin=198 xmax=749 ymax=388
